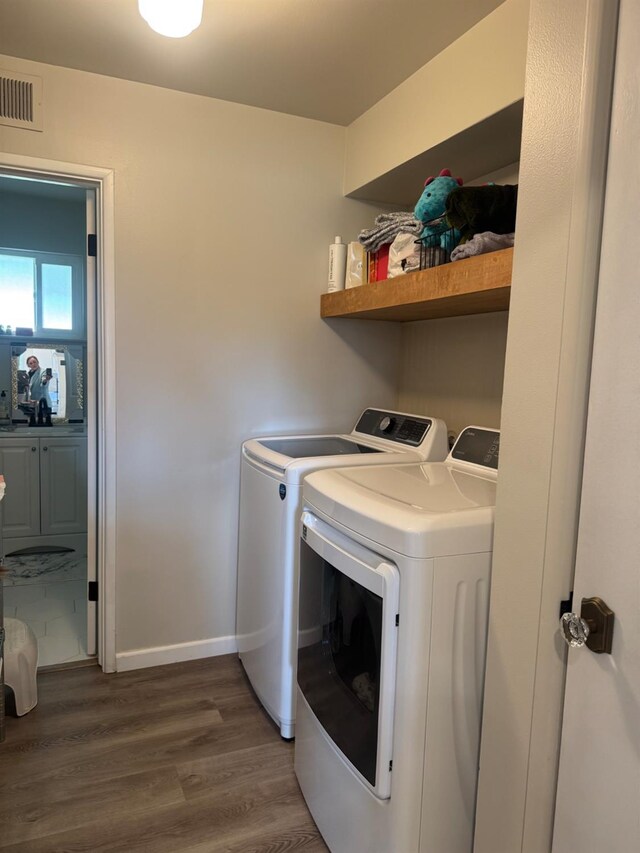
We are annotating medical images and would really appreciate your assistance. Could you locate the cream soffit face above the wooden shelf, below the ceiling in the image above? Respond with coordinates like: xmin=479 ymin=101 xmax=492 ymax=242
xmin=344 ymin=0 xmax=529 ymax=198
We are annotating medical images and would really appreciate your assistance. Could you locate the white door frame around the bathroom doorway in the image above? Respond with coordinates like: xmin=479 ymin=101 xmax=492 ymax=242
xmin=0 ymin=152 xmax=116 ymax=672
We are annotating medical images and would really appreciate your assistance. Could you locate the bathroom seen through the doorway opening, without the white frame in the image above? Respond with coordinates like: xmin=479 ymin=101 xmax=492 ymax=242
xmin=0 ymin=175 xmax=96 ymax=667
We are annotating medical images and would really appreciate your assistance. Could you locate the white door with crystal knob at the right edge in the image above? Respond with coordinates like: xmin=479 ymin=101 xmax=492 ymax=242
xmin=553 ymin=0 xmax=640 ymax=853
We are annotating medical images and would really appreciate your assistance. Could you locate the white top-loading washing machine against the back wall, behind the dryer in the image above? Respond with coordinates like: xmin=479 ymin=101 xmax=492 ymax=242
xmin=236 ymin=409 xmax=448 ymax=738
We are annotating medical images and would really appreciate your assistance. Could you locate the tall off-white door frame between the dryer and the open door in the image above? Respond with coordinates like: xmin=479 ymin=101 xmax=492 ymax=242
xmin=474 ymin=0 xmax=618 ymax=853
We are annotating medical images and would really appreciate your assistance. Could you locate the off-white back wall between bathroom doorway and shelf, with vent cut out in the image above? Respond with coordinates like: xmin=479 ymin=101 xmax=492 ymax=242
xmin=0 ymin=57 xmax=399 ymax=664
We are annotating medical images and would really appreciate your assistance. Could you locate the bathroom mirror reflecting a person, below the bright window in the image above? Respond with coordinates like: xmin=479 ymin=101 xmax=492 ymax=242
xmin=11 ymin=341 xmax=84 ymax=426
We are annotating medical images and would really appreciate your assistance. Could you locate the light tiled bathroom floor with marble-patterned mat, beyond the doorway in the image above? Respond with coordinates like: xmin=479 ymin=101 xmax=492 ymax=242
xmin=4 ymin=554 xmax=90 ymax=667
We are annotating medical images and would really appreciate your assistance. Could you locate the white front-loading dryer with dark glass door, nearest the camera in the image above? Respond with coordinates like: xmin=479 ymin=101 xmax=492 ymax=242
xmin=295 ymin=427 xmax=500 ymax=853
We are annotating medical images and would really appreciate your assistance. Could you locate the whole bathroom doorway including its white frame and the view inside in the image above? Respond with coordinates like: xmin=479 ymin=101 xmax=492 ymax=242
xmin=0 ymin=154 xmax=115 ymax=672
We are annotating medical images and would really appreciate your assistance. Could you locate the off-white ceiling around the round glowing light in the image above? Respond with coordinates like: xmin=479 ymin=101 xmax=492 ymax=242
xmin=0 ymin=0 xmax=503 ymax=125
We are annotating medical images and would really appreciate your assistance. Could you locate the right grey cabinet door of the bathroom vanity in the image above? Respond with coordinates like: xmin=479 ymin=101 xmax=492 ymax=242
xmin=40 ymin=438 xmax=87 ymax=535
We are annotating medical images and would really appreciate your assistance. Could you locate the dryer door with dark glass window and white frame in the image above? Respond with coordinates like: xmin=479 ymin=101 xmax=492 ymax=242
xmin=298 ymin=512 xmax=400 ymax=799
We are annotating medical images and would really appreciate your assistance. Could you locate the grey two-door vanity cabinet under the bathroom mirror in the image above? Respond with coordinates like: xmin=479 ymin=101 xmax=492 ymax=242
xmin=0 ymin=436 xmax=87 ymax=548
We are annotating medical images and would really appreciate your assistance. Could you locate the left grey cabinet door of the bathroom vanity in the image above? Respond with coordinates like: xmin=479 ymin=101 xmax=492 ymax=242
xmin=0 ymin=438 xmax=40 ymax=539
